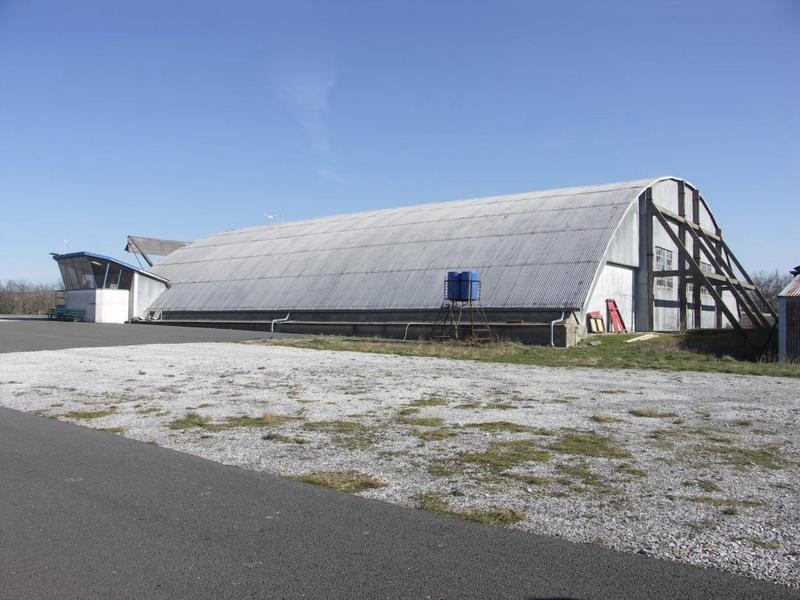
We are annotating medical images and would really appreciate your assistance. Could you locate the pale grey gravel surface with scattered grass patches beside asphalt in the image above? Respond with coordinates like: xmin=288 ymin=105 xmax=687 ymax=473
xmin=0 ymin=343 xmax=800 ymax=587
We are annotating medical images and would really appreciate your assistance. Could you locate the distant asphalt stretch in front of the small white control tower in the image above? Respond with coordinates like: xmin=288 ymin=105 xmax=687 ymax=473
xmin=0 ymin=318 xmax=287 ymax=353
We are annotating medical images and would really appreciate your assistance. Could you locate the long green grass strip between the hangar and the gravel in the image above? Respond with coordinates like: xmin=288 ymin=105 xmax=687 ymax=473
xmin=268 ymin=334 xmax=800 ymax=377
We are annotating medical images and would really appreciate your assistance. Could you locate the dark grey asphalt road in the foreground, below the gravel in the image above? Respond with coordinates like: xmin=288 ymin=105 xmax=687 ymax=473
xmin=0 ymin=408 xmax=800 ymax=600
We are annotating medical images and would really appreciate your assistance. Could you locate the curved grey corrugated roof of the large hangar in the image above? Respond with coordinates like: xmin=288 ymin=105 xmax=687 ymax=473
xmin=150 ymin=179 xmax=659 ymax=311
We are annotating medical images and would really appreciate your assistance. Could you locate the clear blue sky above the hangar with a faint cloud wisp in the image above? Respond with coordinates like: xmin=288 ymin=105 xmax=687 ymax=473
xmin=0 ymin=0 xmax=800 ymax=281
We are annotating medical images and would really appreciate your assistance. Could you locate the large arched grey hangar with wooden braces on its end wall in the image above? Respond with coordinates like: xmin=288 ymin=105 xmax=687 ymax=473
xmin=51 ymin=177 xmax=771 ymax=346
